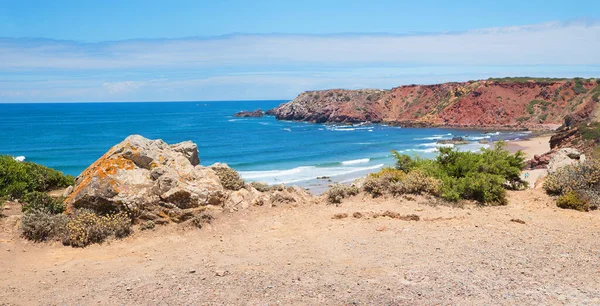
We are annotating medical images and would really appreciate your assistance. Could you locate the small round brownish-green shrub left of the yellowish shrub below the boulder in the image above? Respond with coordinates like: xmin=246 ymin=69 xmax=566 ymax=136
xmin=21 ymin=209 xmax=68 ymax=242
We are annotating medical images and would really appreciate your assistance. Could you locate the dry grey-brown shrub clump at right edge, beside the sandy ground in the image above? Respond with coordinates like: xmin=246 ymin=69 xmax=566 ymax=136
xmin=544 ymin=160 xmax=600 ymax=211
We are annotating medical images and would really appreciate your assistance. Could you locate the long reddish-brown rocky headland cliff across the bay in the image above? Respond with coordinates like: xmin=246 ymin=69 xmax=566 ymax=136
xmin=271 ymin=78 xmax=600 ymax=129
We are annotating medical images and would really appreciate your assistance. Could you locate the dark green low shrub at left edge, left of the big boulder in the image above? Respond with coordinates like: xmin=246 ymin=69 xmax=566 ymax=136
xmin=0 ymin=155 xmax=75 ymax=199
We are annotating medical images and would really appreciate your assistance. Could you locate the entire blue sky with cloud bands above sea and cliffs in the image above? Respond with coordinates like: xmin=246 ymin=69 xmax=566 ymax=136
xmin=0 ymin=0 xmax=600 ymax=103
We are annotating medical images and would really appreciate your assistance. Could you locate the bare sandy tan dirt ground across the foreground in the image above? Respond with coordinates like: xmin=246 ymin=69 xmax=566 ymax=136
xmin=0 ymin=190 xmax=600 ymax=305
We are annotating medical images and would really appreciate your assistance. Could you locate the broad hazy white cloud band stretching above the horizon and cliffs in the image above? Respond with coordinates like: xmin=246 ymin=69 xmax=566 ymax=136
xmin=0 ymin=21 xmax=600 ymax=101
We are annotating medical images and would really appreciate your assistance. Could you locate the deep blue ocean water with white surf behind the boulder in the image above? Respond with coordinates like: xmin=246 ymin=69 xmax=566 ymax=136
xmin=0 ymin=101 xmax=524 ymax=184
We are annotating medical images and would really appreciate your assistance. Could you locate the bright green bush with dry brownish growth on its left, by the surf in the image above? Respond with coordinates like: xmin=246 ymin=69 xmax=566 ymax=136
xmin=363 ymin=142 xmax=527 ymax=205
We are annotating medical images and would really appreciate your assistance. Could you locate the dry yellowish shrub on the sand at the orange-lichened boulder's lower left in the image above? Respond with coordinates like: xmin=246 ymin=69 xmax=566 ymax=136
xmin=63 ymin=209 xmax=131 ymax=247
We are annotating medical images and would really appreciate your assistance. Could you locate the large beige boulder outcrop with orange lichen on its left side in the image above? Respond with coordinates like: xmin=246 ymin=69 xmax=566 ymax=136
xmin=65 ymin=135 xmax=311 ymax=223
